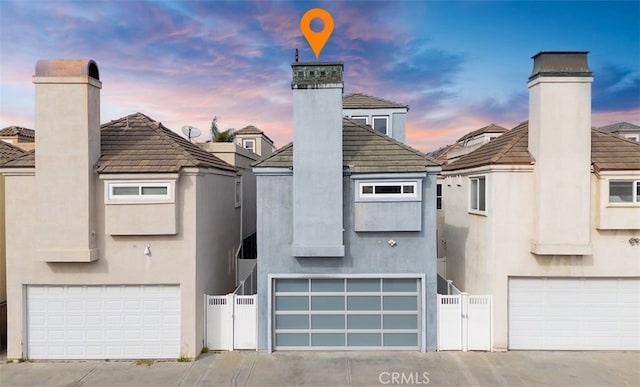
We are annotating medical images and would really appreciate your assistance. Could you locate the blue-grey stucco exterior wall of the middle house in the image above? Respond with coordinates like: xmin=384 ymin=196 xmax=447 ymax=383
xmin=257 ymin=170 xmax=436 ymax=351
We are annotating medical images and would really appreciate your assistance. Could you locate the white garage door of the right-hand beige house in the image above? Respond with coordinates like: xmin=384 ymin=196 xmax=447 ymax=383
xmin=509 ymin=278 xmax=640 ymax=350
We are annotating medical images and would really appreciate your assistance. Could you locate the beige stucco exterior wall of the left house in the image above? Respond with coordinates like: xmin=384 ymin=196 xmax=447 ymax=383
xmin=5 ymin=170 xmax=239 ymax=359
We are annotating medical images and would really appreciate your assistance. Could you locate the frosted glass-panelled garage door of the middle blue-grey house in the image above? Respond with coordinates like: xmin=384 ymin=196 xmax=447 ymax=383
xmin=272 ymin=278 xmax=422 ymax=350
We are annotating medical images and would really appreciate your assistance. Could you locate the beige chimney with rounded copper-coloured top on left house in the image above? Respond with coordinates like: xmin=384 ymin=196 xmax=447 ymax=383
xmin=33 ymin=59 xmax=102 ymax=262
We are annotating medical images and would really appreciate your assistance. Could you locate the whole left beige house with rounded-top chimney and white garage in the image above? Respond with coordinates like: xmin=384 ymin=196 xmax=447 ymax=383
xmin=1 ymin=60 xmax=242 ymax=359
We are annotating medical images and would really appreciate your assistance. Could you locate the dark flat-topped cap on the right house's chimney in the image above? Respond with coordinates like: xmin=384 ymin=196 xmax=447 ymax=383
xmin=529 ymin=51 xmax=593 ymax=81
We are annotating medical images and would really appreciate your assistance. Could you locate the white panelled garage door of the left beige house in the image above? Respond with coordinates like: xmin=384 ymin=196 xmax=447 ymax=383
xmin=27 ymin=285 xmax=180 ymax=359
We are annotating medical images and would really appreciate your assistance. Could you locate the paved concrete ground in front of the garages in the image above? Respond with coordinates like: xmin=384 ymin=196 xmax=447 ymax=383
xmin=0 ymin=351 xmax=640 ymax=387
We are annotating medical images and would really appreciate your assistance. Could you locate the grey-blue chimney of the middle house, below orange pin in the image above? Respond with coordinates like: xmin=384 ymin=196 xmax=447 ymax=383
xmin=291 ymin=62 xmax=344 ymax=257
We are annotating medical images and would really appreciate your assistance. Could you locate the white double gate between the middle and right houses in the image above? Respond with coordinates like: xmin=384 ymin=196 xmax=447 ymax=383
xmin=438 ymin=293 xmax=493 ymax=351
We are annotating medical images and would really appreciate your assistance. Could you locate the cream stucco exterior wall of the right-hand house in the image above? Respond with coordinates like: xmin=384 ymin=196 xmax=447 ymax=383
xmin=443 ymin=168 xmax=640 ymax=350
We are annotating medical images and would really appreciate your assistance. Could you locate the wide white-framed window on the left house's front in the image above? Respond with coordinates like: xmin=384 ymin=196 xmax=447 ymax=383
xmin=106 ymin=181 xmax=175 ymax=204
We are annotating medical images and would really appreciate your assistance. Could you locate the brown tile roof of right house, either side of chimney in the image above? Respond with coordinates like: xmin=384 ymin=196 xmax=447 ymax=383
xmin=443 ymin=121 xmax=640 ymax=171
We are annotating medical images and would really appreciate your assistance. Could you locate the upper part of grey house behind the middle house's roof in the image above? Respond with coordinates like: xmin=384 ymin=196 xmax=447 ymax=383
xmin=342 ymin=93 xmax=409 ymax=142
